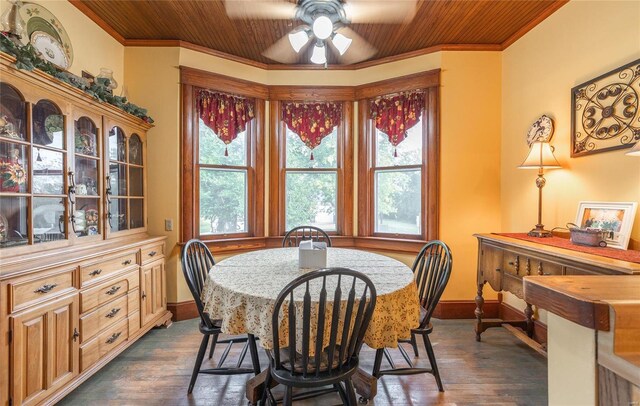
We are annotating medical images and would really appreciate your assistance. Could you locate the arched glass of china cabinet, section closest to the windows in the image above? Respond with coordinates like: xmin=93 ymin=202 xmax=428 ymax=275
xmin=107 ymin=127 xmax=145 ymax=232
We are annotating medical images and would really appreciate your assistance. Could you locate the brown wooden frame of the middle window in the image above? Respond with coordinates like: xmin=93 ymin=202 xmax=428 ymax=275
xmin=269 ymin=86 xmax=354 ymax=237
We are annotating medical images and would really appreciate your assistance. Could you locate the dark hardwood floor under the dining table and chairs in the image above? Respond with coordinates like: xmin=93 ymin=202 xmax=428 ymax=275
xmin=59 ymin=320 xmax=547 ymax=406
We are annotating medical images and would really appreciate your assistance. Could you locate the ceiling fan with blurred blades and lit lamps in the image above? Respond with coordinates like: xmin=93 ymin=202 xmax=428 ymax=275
xmin=225 ymin=0 xmax=417 ymax=67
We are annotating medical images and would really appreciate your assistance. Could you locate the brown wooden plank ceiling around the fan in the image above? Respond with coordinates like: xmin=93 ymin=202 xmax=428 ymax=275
xmin=71 ymin=0 xmax=566 ymax=65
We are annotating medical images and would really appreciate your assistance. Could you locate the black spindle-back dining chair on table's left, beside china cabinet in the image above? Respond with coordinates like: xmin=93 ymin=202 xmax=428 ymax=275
xmin=181 ymin=239 xmax=260 ymax=393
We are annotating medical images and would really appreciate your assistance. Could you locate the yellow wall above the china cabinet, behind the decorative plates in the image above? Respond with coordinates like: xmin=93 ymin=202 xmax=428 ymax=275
xmin=0 ymin=0 xmax=124 ymax=89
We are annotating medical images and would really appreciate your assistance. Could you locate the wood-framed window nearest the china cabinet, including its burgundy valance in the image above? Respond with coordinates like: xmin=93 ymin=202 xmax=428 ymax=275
xmin=181 ymin=68 xmax=268 ymax=247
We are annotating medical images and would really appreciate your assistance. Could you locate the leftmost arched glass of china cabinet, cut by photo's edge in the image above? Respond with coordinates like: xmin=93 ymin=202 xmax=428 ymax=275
xmin=0 ymin=83 xmax=31 ymax=249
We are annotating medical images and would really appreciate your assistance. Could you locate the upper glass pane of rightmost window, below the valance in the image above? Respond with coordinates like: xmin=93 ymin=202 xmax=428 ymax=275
xmin=376 ymin=120 xmax=422 ymax=166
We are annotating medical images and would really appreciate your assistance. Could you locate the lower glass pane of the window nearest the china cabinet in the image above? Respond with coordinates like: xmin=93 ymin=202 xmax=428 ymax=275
xmin=200 ymin=168 xmax=248 ymax=234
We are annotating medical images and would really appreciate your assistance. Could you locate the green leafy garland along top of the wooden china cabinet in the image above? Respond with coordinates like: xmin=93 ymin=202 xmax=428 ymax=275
xmin=0 ymin=33 xmax=153 ymax=123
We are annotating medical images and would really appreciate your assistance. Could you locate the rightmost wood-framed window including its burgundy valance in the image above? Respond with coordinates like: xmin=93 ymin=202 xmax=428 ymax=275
xmin=358 ymin=72 xmax=439 ymax=240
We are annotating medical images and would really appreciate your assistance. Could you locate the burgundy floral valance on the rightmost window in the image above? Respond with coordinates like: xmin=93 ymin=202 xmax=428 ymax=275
xmin=369 ymin=91 xmax=424 ymax=153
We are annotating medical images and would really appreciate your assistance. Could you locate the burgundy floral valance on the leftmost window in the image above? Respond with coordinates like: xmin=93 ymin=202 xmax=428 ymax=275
xmin=198 ymin=90 xmax=254 ymax=156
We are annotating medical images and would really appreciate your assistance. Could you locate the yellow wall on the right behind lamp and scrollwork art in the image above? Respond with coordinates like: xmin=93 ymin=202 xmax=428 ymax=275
xmin=500 ymin=1 xmax=640 ymax=316
